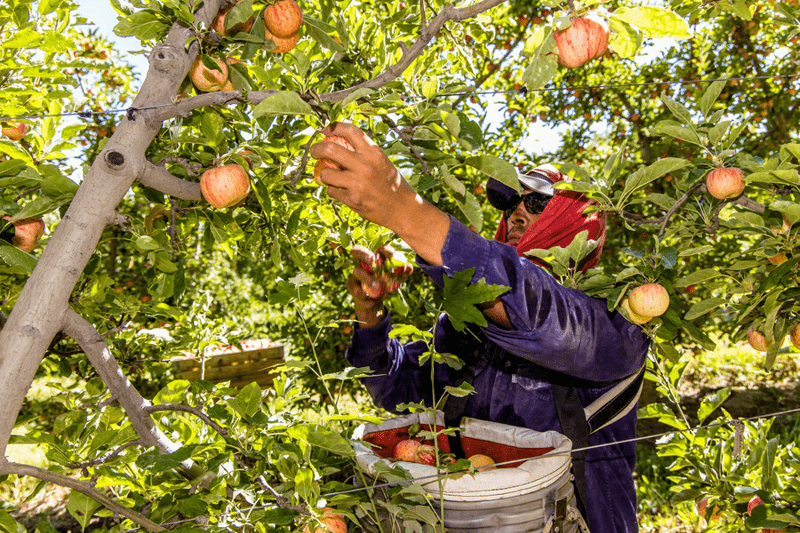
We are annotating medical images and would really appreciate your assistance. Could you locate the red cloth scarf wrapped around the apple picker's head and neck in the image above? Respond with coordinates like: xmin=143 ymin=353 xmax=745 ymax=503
xmin=494 ymin=165 xmax=606 ymax=272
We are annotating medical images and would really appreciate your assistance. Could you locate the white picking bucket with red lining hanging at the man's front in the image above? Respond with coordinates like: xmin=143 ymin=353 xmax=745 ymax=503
xmin=354 ymin=412 xmax=588 ymax=533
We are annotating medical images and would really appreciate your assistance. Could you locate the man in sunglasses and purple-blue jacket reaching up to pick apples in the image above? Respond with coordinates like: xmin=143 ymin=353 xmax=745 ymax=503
xmin=311 ymin=124 xmax=649 ymax=533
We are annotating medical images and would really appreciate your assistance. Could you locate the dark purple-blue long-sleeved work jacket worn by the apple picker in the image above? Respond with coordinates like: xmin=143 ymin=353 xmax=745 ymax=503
xmin=347 ymin=219 xmax=649 ymax=533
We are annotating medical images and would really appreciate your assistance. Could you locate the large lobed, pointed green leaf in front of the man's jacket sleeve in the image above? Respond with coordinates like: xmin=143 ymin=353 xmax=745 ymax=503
xmin=442 ymin=268 xmax=509 ymax=331
